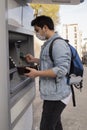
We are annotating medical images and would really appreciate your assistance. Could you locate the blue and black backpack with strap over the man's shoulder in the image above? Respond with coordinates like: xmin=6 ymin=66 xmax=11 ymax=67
xmin=49 ymin=37 xmax=84 ymax=106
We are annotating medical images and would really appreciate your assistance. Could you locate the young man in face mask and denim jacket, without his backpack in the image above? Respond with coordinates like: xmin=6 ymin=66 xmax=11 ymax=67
xmin=25 ymin=16 xmax=71 ymax=130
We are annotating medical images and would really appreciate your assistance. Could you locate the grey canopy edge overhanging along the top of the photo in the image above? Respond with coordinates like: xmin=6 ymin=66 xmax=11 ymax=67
xmin=15 ymin=0 xmax=84 ymax=5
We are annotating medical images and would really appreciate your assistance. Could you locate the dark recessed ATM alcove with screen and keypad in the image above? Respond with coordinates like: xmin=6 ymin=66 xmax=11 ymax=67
xmin=9 ymin=31 xmax=33 ymax=97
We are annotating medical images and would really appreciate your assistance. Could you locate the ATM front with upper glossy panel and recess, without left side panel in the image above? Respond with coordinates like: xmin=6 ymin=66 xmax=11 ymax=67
xmin=8 ymin=0 xmax=35 ymax=130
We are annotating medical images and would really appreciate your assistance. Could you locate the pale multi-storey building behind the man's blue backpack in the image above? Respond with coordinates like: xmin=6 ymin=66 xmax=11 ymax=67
xmin=63 ymin=24 xmax=82 ymax=57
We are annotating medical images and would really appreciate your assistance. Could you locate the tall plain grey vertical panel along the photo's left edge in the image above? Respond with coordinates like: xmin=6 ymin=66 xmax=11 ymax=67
xmin=0 ymin=0 xmax=10 ymax=130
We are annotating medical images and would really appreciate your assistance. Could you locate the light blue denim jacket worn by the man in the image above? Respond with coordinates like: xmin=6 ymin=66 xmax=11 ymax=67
xmin=39 ymin=33 xmax=71 ymax=100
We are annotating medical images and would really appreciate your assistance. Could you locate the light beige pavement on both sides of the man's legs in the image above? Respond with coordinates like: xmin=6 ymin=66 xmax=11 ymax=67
xmin=33 ymin=67 xmax=87 ymax=130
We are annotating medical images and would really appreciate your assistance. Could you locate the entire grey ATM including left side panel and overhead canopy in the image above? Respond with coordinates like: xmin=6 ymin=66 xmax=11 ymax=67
xmin=0 ymin=0 xmax=83 ymax=130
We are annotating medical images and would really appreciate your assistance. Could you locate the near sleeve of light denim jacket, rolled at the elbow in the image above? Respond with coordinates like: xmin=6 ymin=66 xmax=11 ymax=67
xmin=52 ymin=39 xmax=71 ymax=78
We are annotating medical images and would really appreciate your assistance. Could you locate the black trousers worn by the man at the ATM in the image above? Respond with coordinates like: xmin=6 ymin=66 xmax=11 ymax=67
xmin=40 ymin=100 xmax=66 ymax=130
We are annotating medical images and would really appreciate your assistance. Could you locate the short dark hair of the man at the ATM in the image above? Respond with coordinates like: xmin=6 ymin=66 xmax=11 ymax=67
xmin=31 ymin=15 xmax=54 ymax=30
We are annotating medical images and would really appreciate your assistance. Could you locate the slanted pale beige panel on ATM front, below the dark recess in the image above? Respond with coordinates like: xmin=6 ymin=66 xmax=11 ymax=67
xmin=11 ymin=84 xmax=35 ymax=128
